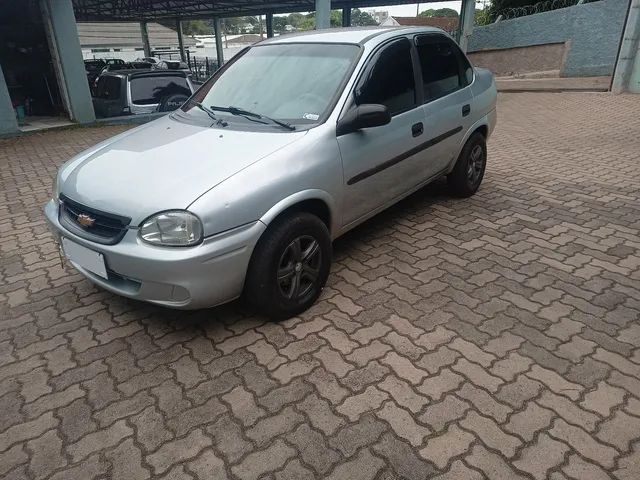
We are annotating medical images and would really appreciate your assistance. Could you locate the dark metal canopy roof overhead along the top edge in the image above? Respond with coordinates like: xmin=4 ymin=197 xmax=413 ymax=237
xmin=73 ymin=0 xmax=448 ymax=22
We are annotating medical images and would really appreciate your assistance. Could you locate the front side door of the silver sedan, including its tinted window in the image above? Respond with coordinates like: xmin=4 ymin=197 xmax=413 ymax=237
xmin=338 ymin=37 xmax=430 ymax=227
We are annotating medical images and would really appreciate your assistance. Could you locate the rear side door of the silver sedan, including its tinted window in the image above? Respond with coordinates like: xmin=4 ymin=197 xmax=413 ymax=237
xmin=414 ymin=33 xmax=473 ymax=171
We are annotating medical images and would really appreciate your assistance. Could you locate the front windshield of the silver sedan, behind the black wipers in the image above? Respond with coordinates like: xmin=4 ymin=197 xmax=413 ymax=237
xmin=182 ymin=43 xmax=359 ymax=125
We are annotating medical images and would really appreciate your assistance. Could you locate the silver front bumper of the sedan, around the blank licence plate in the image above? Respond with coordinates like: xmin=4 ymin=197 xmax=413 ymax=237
xmin=45 ymin=200 xmax=266 ymax=309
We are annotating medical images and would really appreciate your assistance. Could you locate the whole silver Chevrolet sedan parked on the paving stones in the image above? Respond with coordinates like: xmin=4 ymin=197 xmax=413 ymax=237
xmin=45 ymin=28 xmax=496 ymax=318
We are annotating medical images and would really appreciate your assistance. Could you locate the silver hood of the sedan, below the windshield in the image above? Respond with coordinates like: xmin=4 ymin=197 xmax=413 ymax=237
xmin=59 ymin=117 xmax=306 ymax=225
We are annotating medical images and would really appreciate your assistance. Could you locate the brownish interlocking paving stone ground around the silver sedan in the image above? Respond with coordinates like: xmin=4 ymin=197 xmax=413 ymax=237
xmin=0 ymin=93 xmax=640 ymax=480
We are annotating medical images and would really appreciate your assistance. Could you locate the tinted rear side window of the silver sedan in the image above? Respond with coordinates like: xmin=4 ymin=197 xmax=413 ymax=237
xmin=416 ymin=35 xmax=473 ymax=102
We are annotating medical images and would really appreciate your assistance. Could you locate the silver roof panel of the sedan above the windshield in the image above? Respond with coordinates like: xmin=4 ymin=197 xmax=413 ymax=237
xmin=260 ymin=26 xmax=442 ymax=45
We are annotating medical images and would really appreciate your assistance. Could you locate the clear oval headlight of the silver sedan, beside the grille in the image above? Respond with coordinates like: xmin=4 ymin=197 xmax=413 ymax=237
xmin=140 ymin=210 xmax=202 ymax=247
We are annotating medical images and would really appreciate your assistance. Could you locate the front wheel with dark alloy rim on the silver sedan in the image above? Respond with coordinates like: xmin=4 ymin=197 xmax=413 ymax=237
xmin=243 ymin=212 xmax=332 ymax=320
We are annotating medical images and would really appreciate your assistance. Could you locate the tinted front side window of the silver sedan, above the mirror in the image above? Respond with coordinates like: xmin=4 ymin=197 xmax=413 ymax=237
xmin=356 ymin=38 xmax=416 ymax=115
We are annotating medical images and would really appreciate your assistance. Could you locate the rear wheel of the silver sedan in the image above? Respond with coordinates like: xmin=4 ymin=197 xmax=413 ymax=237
xmin=447 ymin=132 xmax=487 ymax=198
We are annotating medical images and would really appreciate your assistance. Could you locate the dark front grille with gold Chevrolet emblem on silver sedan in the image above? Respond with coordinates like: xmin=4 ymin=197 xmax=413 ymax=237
xmin=59 ymin=194 xmax=131 ymax=245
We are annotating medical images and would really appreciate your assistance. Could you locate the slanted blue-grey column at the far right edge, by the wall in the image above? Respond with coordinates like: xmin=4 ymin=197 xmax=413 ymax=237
xmin=611 ymin=0 xmax=640 ymax=93
